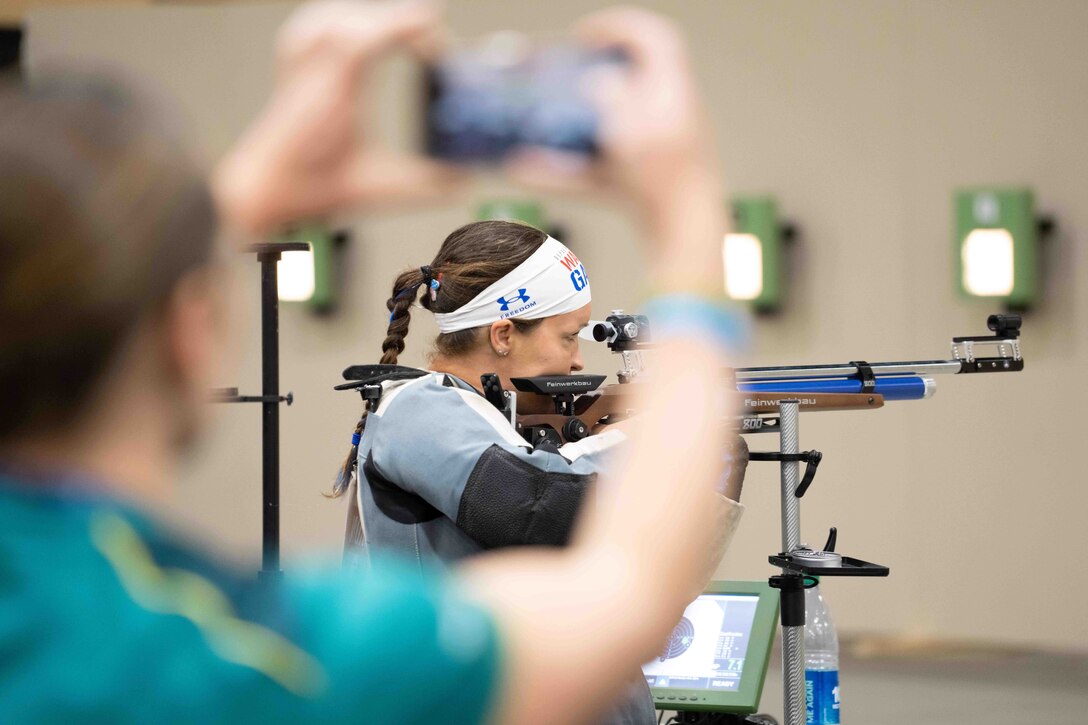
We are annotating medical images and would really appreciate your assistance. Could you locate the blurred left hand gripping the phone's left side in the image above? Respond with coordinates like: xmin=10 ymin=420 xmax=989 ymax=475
xmin=212 ymin=0 xmax=461 ymax=236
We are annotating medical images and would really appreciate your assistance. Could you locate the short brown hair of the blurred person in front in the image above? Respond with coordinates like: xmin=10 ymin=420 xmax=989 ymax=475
xmin=0 ymin=75 xmax=215 ymax=440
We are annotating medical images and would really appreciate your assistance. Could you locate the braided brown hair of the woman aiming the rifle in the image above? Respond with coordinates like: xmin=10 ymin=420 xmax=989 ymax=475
xmin=330 ymin=221 xmax=547 ymax=497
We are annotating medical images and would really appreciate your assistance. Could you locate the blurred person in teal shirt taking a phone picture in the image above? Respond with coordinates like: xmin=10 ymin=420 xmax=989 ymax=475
xmin=0 ymin=2 xmax=740 ymax=723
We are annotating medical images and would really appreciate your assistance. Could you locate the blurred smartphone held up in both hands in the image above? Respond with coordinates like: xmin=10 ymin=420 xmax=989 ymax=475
xmin=423 ymin=33 xmax=625 ymax=163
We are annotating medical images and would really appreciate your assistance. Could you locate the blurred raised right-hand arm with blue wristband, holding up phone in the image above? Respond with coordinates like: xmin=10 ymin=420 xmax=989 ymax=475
xmin=462 ymin=10 xmax=740 ymax=723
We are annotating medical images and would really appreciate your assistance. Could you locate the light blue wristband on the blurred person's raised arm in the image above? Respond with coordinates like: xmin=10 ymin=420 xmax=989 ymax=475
xmin=642 ymin=293 xmax=749 ymax=352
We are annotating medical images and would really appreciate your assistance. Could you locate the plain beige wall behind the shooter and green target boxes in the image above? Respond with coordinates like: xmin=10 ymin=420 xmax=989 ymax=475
xmin=29 ymin=0 xmax=1088 ymax=650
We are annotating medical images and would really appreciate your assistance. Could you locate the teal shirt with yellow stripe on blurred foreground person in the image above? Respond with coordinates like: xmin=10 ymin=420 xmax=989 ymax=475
xmin=0 ymin=478 xmax=498 ymax=724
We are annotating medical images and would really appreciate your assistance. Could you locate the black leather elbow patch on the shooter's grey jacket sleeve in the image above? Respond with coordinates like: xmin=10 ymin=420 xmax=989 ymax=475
xmin=457 ymin=445 xmax=596 ymax=549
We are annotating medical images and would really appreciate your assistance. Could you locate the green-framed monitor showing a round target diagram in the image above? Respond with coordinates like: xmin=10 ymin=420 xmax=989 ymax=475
xmin=642 ymin=581 xmax=778 ymax=714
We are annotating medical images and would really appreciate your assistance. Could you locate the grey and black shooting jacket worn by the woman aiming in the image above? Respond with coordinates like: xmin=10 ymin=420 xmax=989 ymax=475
xmin=345 ymin=372 xmax=657 ymax=725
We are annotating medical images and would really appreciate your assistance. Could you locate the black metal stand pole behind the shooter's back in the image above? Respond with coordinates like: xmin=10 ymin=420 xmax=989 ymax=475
xmin=214 ymin=243 xmax=310 ymax=582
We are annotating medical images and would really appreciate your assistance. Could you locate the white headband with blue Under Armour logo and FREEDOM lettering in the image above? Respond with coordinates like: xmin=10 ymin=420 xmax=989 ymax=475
xmin=434 ymin=236 xmax=590 ymax=332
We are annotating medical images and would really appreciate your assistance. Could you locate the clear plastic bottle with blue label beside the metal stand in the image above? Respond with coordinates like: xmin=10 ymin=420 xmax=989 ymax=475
xmin=805 ymin=585 xmax=840 ymax=725
